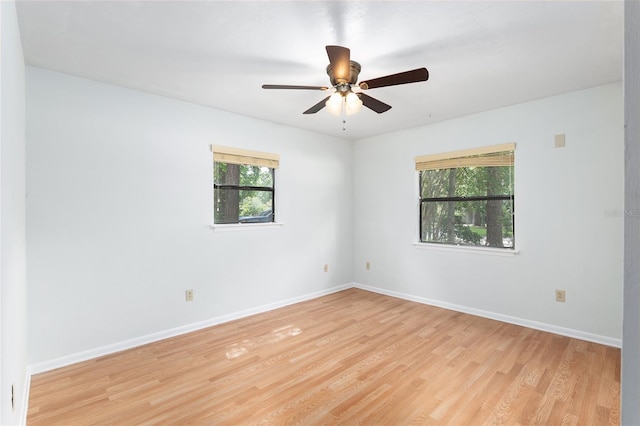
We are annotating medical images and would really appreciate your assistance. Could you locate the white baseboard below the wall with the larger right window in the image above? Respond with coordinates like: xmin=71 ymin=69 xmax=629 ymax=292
xmin=353 ymin=283 xmax=622 ymax=348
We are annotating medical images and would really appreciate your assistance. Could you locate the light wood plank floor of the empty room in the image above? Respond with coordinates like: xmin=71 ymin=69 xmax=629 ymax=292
xmin=28 ymin=289 xmax=620 ymax=425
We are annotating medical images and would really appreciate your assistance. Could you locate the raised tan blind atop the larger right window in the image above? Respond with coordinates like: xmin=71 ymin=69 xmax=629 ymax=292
xmin=415 ymin=143 xmax=516 ymax=170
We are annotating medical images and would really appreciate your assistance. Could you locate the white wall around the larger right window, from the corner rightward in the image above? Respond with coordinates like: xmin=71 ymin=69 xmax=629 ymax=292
xmin=353 ymin=84 xmax=624 ymax=345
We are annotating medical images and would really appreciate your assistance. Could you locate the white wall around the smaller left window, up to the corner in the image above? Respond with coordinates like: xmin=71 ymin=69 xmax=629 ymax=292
xmin=27 ymin=67 xmax=352 ymax=364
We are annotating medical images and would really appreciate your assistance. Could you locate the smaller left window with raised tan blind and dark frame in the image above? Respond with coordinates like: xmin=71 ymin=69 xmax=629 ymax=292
xmin=213 ymin=146 xmax=279 ymax=224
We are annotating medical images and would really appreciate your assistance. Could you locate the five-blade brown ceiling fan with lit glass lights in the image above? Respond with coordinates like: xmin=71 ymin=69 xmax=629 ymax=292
xmin=262 ymin=46 xmax=429 ymax=115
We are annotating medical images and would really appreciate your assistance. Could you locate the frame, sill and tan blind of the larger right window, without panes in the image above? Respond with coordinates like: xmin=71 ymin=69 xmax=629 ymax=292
xmin=414 ymin=143 xmax=518 ymax=250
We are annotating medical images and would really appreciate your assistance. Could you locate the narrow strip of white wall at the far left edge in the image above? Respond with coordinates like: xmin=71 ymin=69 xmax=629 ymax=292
xmin=0 ymin=1 xmax=27 ymax=425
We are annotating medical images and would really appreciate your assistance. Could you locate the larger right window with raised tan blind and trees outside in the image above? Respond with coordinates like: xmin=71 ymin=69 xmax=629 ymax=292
xmin=416 ymin=144 xmax=515 ymax=249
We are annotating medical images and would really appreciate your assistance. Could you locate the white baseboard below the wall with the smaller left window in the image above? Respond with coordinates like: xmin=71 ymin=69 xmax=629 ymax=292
xmin=29 ymin=284 xmax=352 ymax=374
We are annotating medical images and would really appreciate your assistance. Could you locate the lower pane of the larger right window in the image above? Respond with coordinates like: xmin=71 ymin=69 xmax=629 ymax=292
xmin=420 ymin=199 xmax=514 ymax=248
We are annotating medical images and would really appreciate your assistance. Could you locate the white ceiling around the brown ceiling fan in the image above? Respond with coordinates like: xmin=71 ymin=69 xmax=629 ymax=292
xmin=17 ymin=0 xmax=623 ymax=139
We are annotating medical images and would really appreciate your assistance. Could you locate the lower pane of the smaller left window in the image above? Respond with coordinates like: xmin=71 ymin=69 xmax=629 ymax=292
xmin=214 ymin=188 xmax=273 ymax=223
